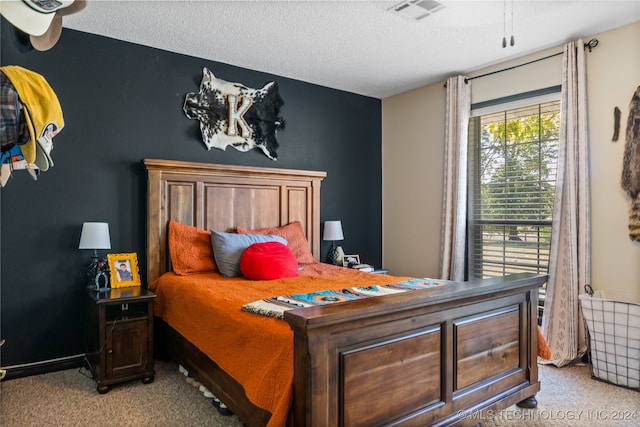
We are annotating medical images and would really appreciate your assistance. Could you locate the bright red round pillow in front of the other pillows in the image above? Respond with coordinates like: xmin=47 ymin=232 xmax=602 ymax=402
xmin=240 ymin=242 xmax=298 ymax=280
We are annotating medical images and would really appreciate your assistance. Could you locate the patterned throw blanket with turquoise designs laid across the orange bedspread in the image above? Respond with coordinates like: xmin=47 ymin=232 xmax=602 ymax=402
xmin=242 ymin=279 xmax=456 ymax=319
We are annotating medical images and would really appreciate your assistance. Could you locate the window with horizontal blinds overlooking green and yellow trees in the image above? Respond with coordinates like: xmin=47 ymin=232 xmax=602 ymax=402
xmin=467 ymin=97 xmax=560 ymax=284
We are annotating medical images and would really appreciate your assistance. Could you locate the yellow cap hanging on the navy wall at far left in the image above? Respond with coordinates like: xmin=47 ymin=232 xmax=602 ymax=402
xmin=0 ymin=65 xmax=64 ymax=171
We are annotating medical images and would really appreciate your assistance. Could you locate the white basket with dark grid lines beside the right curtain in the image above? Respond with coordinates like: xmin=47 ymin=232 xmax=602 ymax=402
xmin=579 ymin=291 xmax=640 ymax=390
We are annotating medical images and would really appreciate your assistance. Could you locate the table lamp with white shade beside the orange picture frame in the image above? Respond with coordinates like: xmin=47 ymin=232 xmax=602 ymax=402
xmin=78 ymin=222 xmax=111 ymax=290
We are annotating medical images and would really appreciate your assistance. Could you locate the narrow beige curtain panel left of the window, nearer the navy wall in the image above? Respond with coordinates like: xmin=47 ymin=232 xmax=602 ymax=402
xmin=440 ymin=76 xmax=471 ymax=280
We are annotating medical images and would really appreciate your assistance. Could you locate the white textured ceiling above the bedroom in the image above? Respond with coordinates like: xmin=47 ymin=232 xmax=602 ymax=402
xmin=63 ymin=0 xmax=640 ymax=98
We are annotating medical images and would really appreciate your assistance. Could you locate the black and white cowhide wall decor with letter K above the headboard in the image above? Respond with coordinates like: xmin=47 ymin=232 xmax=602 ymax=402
xmin=182 ymin=67 xmax=284 ymax=160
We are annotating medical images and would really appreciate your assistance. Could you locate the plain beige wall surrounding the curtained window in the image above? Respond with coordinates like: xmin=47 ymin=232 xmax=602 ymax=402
xmin=383 ymin=23 xmax=640 ymax=293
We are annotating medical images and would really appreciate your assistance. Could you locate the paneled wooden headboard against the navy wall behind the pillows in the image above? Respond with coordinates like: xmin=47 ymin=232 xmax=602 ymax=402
xmin=143 ymin=159 xmax=327 ymax=283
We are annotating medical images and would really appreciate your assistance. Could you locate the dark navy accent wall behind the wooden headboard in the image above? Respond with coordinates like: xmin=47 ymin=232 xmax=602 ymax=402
xmin=0 ymin=24 xmax=382 ymax=367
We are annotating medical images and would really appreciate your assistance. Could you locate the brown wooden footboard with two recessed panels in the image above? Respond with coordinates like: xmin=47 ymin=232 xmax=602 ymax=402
xmin=285 ymin=274 xmax=547 ymax=427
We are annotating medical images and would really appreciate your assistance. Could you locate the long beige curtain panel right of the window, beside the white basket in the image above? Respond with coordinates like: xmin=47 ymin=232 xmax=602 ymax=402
xmin=540 ymin=40 xmax=591 ymax=366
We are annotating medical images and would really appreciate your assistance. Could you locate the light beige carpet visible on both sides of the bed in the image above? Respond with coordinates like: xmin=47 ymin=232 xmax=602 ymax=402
xmin=0 ymin=361 xmax=640 ymax=427
